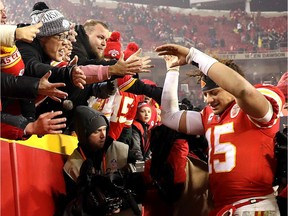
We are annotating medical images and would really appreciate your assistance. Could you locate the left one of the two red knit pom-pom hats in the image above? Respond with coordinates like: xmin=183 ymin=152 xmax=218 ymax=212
xmin=104 ymin=31 xmax=121 ymax=59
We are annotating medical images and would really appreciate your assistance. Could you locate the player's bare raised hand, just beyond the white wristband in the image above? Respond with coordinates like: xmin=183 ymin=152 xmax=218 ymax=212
xmin=155 ymin=44 xmax=189 ymax=67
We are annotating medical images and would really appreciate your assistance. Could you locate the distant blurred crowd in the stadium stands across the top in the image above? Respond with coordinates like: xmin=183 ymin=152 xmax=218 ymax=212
xmin=4 ymin=0 xmax=287 ymax=52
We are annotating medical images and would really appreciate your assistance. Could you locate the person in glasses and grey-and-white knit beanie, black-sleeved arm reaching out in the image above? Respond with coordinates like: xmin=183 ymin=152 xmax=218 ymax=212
xmin=16 ymin=6 xmax=85 ymax=88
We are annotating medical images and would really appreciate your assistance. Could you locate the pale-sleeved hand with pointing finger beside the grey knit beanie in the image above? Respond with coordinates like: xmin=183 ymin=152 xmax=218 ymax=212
xmin=15 ymin=22 xmax=43 ymax=43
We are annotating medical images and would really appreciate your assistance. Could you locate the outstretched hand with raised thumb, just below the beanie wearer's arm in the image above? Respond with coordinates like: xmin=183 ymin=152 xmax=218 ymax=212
xmin=38 ymin=71 xmax=68 ymax=102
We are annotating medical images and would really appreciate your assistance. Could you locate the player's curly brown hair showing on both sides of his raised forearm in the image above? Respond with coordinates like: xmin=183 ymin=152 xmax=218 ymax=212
xmin=187 ymin=56 xmax=245 ymax=83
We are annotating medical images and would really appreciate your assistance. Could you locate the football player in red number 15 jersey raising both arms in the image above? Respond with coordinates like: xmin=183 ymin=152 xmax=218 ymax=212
xmin=156 ymin=44 xmax=284 ymax=216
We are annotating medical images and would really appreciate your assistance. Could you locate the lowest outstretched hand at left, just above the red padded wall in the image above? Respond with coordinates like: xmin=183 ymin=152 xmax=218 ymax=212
xmin=25 ymin=111 xmax=66 ymax=136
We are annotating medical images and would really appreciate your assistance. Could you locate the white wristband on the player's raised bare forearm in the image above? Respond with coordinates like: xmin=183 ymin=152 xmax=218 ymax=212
xmin=186 ymin=47 xmax=218 ymax=76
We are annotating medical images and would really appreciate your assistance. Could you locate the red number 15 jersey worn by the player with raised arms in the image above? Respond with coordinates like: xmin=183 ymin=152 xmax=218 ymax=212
xmin=202 ymin=85 xmax=284 ymax=208
